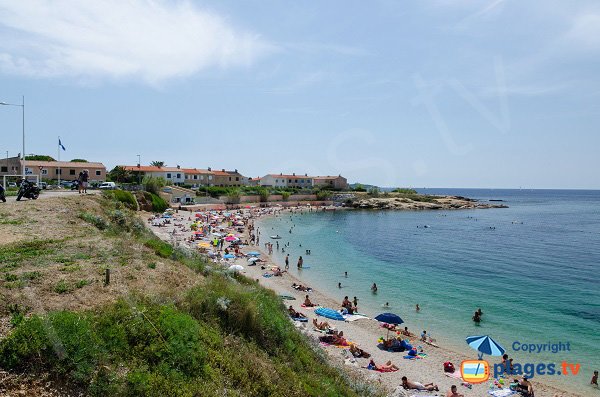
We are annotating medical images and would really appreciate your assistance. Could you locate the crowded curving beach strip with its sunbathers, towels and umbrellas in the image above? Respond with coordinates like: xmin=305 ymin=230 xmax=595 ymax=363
xmin=147 ymin=205 xmax=577 ymax=397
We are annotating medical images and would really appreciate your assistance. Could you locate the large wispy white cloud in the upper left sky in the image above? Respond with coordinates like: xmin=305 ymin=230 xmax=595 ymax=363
xmin=0 ymin=0 xmax=274 ymax=84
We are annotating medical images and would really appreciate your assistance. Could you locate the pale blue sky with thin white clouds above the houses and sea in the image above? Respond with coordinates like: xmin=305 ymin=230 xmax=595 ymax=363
xmin=0 ymin=0 xmax=600 ymax=189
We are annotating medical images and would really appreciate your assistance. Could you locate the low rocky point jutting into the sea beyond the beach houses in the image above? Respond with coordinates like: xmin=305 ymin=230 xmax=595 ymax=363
xmin=345 ymin=195 xmax=508 ymax=210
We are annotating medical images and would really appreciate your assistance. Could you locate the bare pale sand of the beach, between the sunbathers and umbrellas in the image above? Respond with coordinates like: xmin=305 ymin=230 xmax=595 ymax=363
xmin=143 ymin=208 xmax=583 ymax=397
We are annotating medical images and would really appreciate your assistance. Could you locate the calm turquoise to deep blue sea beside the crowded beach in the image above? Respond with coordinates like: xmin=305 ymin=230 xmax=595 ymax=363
xmin=260 ymin=189 xmax=600 ymax=393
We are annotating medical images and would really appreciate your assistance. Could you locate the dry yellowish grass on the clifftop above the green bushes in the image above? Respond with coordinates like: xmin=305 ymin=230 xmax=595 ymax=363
xmin=0 ymin=196 xmax=202 ymax=322
